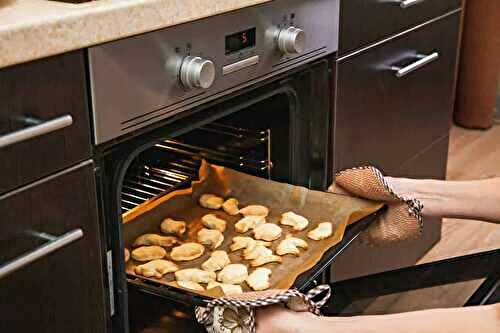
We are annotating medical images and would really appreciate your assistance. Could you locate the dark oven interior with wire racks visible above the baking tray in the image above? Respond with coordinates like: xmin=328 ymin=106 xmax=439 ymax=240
xmin=121 ymin=94 xmax=294 ymax=214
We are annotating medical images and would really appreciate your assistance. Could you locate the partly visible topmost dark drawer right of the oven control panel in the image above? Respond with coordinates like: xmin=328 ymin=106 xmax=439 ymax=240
xmin=339 ymin=0 xmax=462 ymax=54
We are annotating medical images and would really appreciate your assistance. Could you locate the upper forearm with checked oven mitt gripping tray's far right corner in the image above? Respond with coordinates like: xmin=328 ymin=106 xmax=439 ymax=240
xmin=328 ymin=166 xmax=500 ymax=246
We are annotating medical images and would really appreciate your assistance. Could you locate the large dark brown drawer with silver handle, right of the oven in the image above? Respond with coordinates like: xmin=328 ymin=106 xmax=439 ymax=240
xmin=334 ymin=14 xmax=460 ymax=174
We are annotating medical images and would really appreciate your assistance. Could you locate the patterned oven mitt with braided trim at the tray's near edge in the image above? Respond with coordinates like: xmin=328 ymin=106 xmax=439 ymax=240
xmin=195 ymin=285 xmax=331 ymax=333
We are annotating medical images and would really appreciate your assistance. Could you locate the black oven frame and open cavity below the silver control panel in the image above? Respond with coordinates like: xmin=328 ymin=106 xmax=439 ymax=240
xmin=98 ymin=59 xmax=333 ymax=332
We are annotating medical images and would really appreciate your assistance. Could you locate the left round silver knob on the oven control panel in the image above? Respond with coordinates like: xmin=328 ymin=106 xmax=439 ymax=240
xmin=180 ymin=56 xmax=215 ymax=89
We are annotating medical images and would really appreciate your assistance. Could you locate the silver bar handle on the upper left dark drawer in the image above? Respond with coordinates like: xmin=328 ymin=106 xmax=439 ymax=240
xmin=0 ymin=115 xmax=73 ymax=148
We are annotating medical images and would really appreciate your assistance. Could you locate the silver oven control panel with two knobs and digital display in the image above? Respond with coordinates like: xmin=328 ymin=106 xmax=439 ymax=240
xmin=89 ymin=0 xmax=340 ymax=144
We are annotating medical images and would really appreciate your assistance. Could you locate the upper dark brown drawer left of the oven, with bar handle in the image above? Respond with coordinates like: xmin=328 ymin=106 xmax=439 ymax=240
xmin=0 ymin=51 xmax=91 ymax=193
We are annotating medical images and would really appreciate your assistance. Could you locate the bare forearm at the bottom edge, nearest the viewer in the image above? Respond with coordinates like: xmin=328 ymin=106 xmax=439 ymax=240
xmin=257 ymin=304 xmax=500 ymax=333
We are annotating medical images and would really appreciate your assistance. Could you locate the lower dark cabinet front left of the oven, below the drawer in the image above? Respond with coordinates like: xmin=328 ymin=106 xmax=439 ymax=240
xmin=0 ymin=162 xmax=106 ymax=333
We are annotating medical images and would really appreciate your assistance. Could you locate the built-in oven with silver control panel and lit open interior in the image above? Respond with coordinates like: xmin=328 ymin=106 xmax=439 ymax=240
xmin=88 ymin=0 xmax=339 ymax=332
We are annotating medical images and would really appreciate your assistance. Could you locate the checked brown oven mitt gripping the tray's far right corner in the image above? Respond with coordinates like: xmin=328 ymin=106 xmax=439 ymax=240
xmin=328 ymin=166 xmax=423 ymax=246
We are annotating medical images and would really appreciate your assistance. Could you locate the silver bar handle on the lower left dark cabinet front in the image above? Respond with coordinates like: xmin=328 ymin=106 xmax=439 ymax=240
xmin=0 ymin=229 xmax=83 ymax=279
